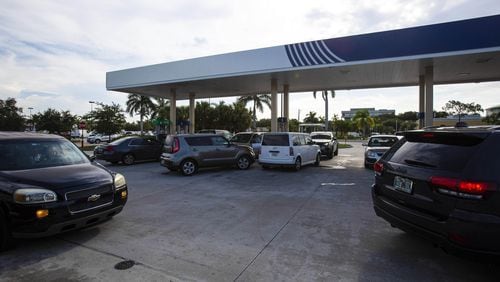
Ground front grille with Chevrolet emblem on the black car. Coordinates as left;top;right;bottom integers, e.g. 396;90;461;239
65;184;114;213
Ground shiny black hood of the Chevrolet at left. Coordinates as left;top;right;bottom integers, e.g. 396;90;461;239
0;164;113;190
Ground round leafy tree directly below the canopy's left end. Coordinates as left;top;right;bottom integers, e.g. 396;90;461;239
92;103;126;141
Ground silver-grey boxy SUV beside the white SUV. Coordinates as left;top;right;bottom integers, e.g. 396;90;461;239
161;134;255;175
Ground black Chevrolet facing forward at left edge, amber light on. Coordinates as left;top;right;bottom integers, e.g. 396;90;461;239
0;132;128;250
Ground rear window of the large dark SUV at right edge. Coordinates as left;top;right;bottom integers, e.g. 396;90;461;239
387;133;484;172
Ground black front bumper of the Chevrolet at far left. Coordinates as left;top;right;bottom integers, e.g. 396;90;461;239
10;188;128;238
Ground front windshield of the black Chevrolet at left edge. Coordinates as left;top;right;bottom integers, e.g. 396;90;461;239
0;140;89;171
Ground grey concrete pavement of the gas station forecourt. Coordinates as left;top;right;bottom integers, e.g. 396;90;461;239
0;142;500;281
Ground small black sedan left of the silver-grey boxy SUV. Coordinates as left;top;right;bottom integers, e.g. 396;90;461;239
94;136;163;165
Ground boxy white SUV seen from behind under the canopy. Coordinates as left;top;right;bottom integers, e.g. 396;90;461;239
259;132;321;170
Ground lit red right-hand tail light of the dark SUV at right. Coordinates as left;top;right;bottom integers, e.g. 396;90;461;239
430;176;494;199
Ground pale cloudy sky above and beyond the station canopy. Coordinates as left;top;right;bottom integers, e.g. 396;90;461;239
0;0;500;120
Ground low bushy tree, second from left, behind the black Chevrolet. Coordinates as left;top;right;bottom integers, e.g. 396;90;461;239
33;108;78;134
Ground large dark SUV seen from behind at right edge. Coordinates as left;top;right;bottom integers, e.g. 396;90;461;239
372;128;500;255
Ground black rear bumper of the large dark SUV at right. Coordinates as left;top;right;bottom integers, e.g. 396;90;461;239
372;185;500;256
